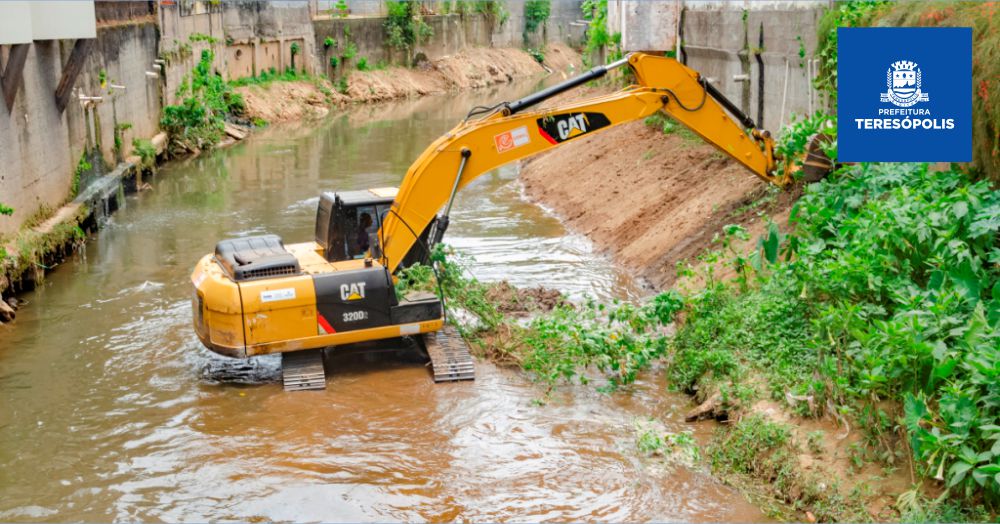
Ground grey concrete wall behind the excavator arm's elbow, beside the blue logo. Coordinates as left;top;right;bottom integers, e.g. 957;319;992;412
608;0;830;131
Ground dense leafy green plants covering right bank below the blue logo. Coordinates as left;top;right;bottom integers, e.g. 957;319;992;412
668;155;1000;501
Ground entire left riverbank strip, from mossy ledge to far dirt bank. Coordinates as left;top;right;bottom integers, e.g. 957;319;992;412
0;44;580;322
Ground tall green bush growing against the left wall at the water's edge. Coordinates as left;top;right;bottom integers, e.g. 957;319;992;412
160;49;246;150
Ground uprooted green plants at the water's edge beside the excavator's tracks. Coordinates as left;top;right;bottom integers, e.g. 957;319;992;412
397;248;682;390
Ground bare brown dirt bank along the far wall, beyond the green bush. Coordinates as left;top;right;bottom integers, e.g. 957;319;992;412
236;44;580;122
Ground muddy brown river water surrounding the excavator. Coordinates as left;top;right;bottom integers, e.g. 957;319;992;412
0;77;764;521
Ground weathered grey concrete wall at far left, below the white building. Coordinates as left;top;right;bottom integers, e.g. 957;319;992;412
0;23;160;234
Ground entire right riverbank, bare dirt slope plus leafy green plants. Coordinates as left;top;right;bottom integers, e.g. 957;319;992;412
506;89;1000;521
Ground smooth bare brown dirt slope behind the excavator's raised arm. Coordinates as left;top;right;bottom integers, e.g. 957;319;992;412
521;121;791;288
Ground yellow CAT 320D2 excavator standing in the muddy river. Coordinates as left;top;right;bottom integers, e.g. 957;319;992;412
191;53;828;390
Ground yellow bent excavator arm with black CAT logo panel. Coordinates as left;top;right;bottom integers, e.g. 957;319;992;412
378;53;789;272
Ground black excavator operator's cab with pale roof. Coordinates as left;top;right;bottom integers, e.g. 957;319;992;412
316;187;397;262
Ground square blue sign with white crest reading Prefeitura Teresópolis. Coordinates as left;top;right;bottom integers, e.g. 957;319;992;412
837;27;972;162
